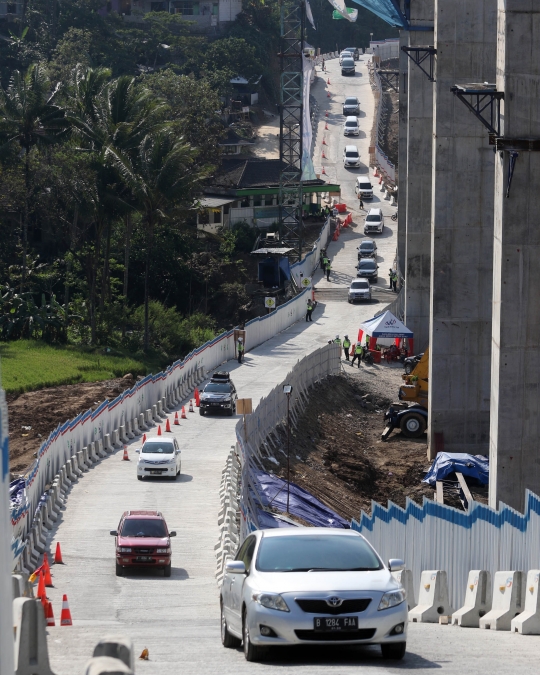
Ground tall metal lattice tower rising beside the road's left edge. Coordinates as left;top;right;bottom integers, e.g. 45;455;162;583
279;0;306;260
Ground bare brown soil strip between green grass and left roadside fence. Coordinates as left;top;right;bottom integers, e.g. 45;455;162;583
7;374;135;474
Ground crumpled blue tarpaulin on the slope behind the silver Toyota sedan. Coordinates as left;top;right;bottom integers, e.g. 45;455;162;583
251;470;351;528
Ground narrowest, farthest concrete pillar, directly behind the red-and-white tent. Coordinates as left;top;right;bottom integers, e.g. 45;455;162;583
400;0;435;352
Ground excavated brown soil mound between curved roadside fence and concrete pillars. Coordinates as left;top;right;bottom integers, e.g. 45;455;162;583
265;368;438;520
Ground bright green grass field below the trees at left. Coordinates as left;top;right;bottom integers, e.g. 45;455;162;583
0;340;166;393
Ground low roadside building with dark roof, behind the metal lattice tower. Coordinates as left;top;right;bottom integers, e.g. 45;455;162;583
197;157;340;232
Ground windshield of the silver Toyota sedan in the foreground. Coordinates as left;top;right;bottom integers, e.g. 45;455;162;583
256;534;382;572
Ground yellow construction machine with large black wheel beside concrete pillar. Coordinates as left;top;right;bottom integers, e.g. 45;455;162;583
381;349;429;441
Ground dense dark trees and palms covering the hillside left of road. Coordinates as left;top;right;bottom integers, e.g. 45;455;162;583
0;0;394;370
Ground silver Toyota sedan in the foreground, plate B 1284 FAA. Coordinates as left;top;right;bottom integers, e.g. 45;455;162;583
220;527;408;661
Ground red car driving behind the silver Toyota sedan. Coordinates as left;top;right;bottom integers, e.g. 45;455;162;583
111;511;176;577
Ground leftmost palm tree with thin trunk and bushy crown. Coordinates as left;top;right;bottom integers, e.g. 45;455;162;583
0;63;67;292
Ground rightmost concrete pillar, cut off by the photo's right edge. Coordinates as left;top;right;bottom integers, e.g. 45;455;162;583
489;0;540;511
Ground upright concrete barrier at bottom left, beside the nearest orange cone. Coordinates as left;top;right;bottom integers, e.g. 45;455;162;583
13;598;53;675
